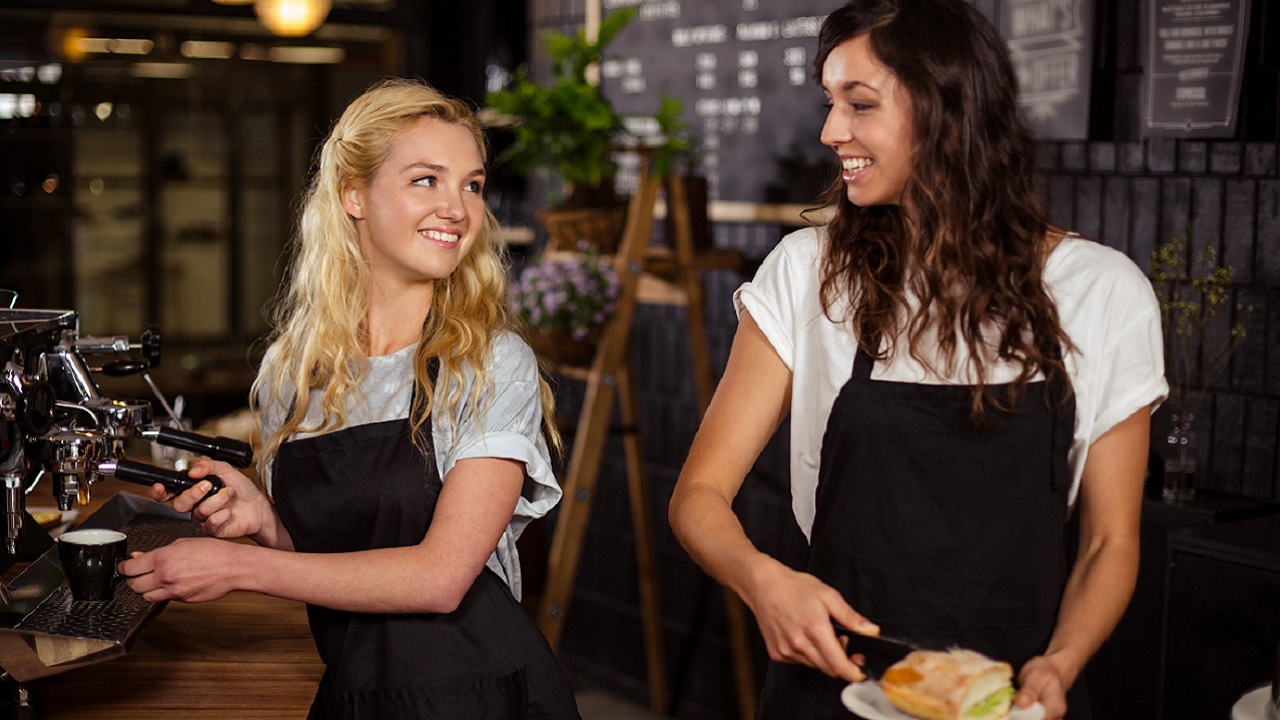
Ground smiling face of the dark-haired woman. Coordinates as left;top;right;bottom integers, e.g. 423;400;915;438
822;35;915;208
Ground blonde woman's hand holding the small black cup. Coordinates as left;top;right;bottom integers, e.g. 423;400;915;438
119;532;243;602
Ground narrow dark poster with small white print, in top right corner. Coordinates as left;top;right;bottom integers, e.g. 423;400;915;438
1146;0;1249;137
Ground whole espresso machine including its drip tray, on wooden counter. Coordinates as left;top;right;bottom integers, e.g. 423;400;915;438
0;307;253;717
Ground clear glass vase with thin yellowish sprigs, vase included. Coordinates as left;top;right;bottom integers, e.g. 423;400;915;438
1149;228;1248;503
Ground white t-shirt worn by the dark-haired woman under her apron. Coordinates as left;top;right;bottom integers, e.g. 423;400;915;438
733;228;1169;537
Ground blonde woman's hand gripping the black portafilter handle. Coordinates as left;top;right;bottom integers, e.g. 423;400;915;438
151;457;292;550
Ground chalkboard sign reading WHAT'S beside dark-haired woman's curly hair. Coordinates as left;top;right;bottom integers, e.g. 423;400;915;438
996;0;1093;140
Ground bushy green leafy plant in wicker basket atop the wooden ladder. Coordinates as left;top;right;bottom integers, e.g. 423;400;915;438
486;8;689;251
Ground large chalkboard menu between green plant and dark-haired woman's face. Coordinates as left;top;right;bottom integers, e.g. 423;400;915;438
600;0;838;202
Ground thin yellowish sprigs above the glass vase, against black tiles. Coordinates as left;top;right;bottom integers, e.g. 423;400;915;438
1149;228;1249;421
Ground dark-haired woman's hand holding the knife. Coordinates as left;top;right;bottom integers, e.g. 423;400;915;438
745;559;879;682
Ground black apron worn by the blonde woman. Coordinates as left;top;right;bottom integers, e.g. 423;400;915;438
274;376;579;720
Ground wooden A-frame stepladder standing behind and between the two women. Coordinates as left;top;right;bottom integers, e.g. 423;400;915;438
538;154;755;720
